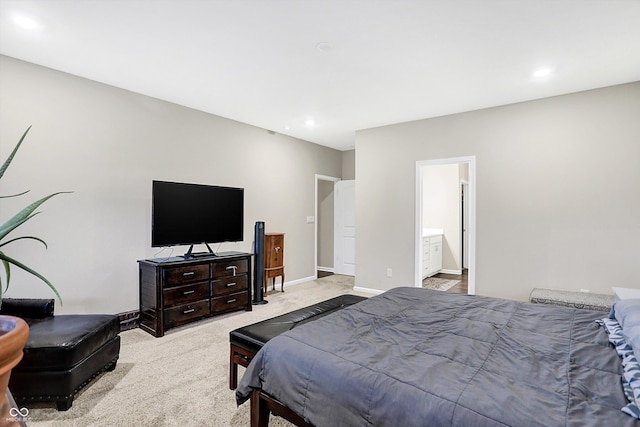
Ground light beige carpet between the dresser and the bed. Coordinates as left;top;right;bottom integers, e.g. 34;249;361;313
26;275;370;427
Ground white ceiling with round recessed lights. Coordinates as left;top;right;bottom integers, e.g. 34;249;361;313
0;0;640;150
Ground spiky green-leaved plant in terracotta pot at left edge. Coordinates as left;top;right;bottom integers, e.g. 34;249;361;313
0;126;62;421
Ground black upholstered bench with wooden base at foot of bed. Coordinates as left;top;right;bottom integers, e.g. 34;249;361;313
229;295;366;390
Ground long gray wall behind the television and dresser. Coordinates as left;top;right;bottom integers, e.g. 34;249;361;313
0;56;342;313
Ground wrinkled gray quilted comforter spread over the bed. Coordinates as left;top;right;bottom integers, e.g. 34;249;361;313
236;288;638;427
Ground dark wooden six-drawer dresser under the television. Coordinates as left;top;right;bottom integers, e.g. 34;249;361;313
138;252;252;337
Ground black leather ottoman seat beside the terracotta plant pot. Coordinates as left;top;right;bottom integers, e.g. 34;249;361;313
2;299;120;411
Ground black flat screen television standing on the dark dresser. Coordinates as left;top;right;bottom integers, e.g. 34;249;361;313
151;181;244;257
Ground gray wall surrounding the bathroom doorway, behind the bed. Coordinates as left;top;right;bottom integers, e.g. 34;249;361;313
356;82;640;300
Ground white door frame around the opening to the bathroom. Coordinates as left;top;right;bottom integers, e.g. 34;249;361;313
414;156;476;295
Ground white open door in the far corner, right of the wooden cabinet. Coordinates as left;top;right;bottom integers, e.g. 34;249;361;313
333;180;356;276
